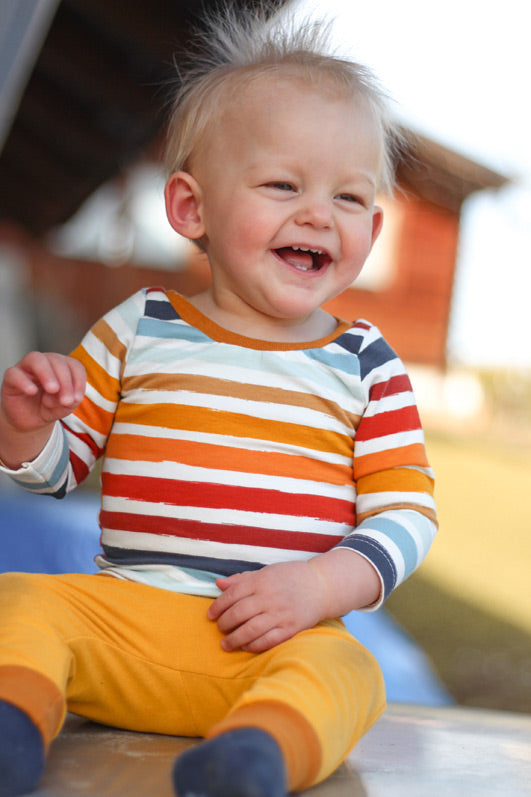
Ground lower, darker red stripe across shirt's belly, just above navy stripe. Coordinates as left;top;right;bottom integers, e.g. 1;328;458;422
100;511;343;553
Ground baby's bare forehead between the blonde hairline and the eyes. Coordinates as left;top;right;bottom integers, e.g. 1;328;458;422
191;75;382;182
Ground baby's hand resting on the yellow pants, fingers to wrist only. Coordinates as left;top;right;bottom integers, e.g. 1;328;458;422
208;562;326;653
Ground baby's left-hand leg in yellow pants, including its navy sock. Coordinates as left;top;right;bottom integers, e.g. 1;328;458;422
0;573;238;797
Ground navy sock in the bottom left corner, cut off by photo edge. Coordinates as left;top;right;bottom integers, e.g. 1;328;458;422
0;700;45;797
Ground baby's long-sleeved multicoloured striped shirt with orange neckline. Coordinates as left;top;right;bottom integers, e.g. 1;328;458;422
5;288;435;599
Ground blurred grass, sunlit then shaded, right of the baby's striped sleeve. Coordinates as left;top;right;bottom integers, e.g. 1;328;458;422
386;435;531;713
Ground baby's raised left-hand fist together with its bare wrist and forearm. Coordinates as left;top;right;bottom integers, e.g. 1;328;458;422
0;352;86;470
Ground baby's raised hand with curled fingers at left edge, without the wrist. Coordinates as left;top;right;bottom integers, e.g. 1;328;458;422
1;352;86;432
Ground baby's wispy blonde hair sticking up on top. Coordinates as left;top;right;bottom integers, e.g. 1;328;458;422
165;3;401;193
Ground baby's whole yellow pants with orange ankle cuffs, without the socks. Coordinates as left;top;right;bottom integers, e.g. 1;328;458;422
0;573;385;790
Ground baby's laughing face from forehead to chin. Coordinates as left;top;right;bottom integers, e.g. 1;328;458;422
190;77;382;336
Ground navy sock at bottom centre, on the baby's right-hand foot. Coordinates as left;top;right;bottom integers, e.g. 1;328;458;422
173;728;287;797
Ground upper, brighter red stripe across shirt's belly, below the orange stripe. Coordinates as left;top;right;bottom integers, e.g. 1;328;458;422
102;473;354;525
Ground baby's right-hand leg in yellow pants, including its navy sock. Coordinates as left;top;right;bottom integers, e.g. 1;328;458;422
174;621;385;797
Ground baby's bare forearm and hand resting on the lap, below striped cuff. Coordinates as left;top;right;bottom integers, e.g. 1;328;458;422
208;548;381;653
